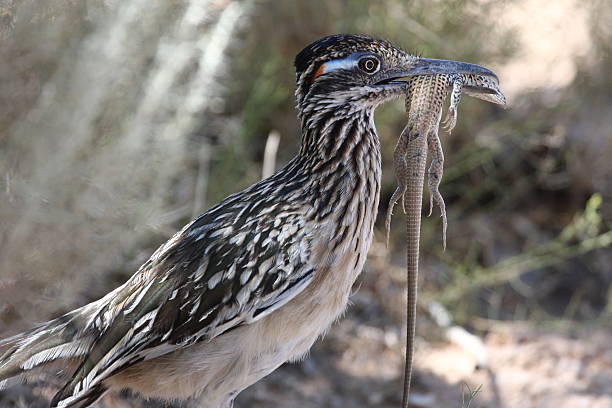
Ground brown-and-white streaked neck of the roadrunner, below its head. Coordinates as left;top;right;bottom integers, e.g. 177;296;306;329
296;105;381;226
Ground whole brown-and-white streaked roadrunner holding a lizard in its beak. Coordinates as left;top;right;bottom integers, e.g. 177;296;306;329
0;35;493;408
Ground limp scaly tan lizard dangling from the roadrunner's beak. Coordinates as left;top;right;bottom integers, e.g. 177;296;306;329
386;74;505;407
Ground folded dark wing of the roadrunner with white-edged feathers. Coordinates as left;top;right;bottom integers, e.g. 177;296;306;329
52;197;314;407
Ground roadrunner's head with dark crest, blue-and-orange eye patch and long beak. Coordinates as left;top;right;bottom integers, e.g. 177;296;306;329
295;34;498;114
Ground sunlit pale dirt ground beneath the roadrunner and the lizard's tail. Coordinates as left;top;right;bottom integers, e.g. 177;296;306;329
0;289;612;408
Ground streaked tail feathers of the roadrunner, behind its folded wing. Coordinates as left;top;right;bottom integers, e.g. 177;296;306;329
0;305;94;390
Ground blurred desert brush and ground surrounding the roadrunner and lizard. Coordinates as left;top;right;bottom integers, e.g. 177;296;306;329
0;0;612;408
